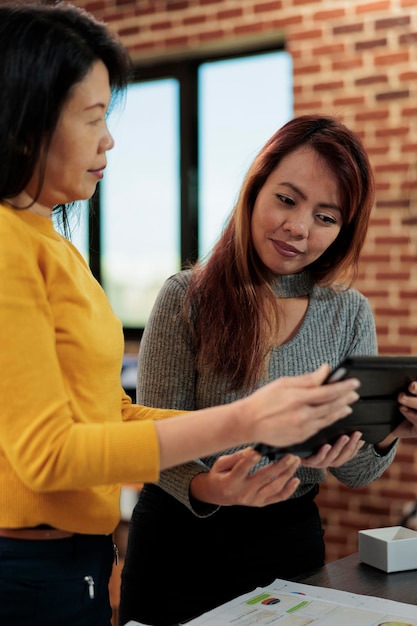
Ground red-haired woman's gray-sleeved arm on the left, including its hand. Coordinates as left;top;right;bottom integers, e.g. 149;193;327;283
138;273;358;508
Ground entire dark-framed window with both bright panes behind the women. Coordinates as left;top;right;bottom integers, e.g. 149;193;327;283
80;44;293;339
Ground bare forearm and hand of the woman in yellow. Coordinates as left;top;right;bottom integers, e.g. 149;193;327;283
155;365;360;468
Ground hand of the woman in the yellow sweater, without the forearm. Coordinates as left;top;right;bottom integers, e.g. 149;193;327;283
240;364;360;447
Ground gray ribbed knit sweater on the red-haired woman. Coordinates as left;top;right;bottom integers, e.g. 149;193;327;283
137;270;397;517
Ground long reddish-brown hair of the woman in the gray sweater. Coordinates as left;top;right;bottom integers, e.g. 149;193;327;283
185;115;374;389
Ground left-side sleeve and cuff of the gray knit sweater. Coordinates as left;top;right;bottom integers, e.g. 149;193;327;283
137;272;218;516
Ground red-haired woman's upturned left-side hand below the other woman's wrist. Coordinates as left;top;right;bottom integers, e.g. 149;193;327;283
190;447;300;507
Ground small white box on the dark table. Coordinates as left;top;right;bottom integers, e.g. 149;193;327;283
358;526;417;572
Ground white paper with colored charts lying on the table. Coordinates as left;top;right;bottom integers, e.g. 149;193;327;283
188;579;417;626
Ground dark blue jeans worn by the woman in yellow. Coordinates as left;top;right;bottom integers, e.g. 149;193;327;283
0;535;114;626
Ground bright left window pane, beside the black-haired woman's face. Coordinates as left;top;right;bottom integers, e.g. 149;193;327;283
100;79;181;327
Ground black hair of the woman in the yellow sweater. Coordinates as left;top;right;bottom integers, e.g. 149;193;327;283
0;2;131;230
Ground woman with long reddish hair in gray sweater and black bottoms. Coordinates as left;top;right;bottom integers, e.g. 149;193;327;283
120;115;414;626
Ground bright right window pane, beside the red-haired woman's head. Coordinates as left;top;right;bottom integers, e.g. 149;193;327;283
198;52;293;257
